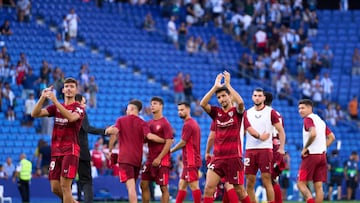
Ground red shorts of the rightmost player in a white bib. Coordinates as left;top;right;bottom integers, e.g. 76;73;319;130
298;153;328;182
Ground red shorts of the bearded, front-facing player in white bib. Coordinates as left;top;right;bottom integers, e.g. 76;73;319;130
244;149;273;175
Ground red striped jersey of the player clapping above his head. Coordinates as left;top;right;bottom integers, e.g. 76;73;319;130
209;106;243;159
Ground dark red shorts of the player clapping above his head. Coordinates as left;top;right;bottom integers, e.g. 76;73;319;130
208;157;244;185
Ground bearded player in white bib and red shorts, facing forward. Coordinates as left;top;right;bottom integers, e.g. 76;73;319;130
244;88;285;203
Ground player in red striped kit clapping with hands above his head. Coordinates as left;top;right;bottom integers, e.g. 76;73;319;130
200;71;268;203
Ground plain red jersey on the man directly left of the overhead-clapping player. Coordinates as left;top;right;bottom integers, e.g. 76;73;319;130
181;118;202;168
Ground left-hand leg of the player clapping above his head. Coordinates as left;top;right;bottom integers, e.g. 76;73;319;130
204;169;220;203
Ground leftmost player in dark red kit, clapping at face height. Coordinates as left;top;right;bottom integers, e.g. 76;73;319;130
31;78;84;203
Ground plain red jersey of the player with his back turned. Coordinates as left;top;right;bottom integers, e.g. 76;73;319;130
115;115;150;167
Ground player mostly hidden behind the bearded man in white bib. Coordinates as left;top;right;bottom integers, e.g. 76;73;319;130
264;92;286;203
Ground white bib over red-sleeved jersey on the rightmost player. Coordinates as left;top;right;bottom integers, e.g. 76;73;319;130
303;113;332;154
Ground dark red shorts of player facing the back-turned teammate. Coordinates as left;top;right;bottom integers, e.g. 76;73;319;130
141;163;170;186
